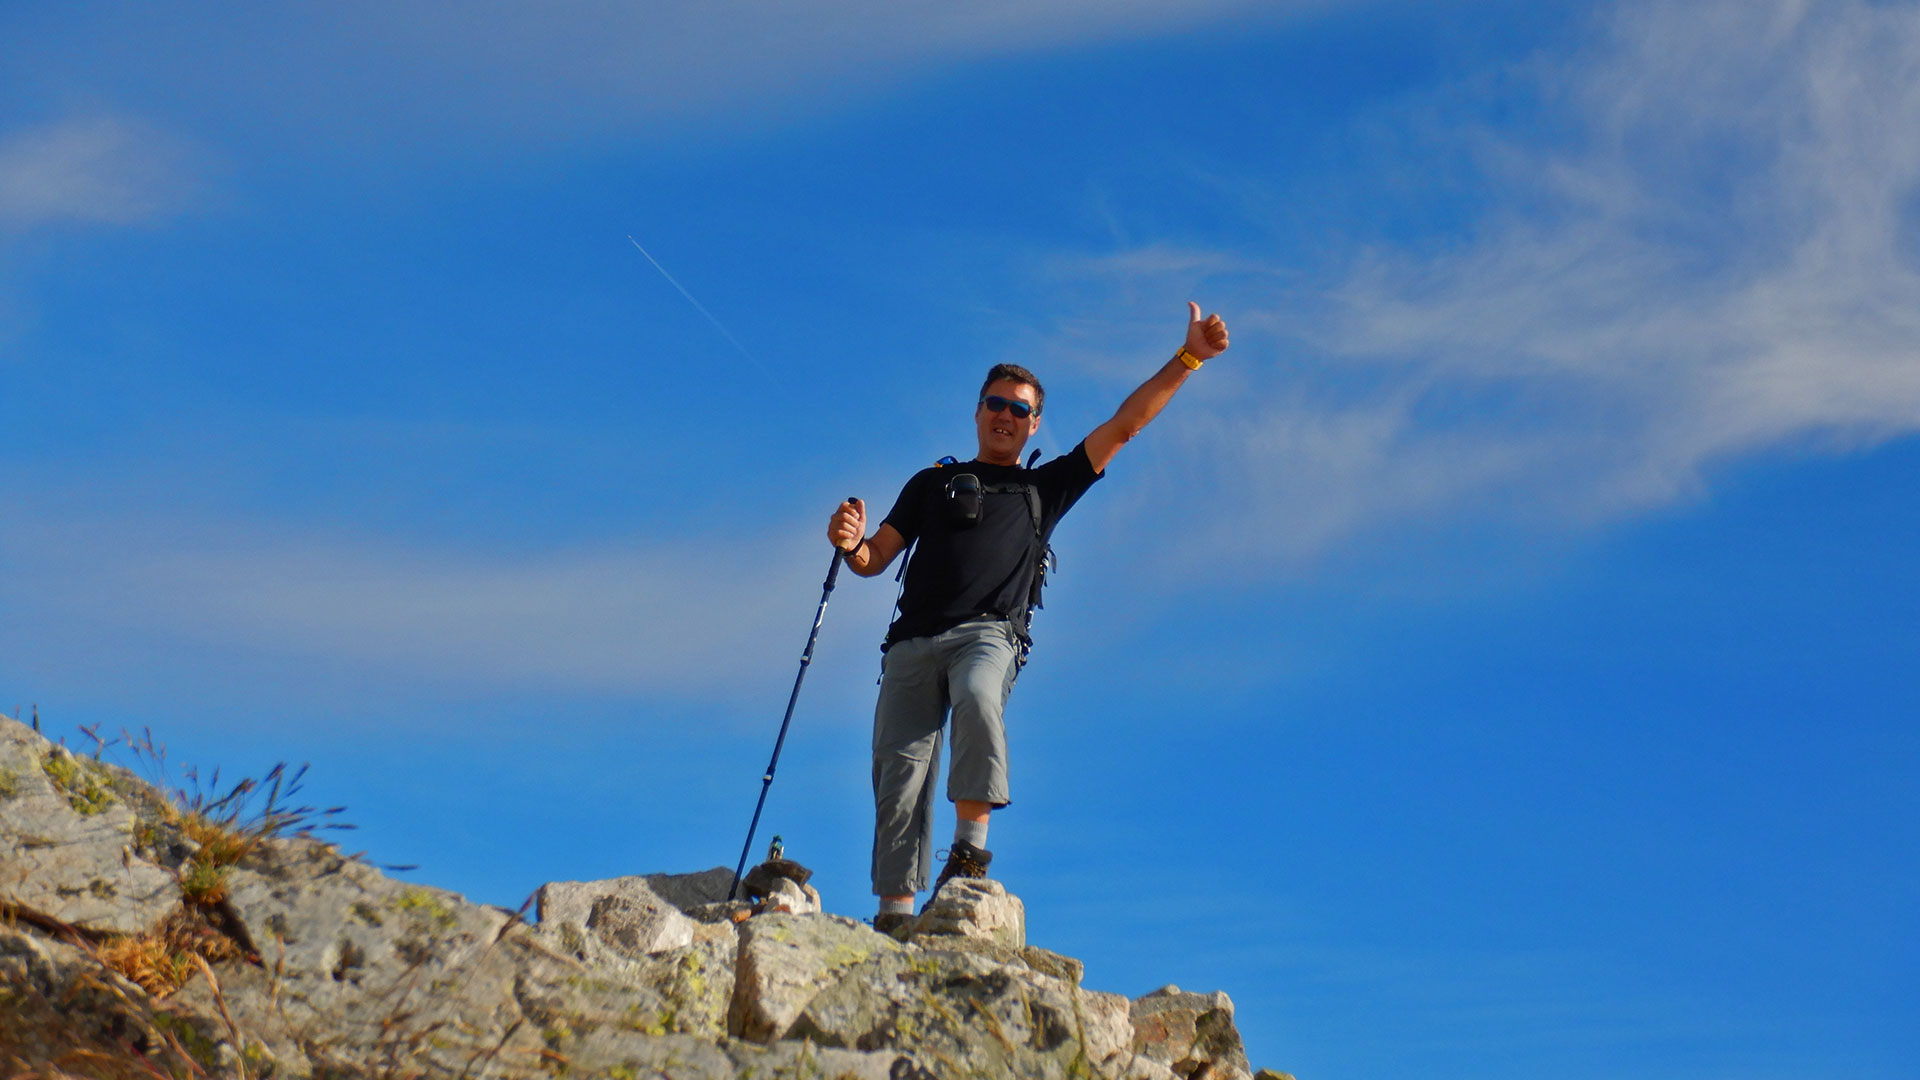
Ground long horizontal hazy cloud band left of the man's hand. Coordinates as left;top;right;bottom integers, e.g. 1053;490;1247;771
0;515;891;705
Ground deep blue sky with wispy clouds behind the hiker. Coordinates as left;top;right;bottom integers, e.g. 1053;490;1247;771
0;0;1920;1080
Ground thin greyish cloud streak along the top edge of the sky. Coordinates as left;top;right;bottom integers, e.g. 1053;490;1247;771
0;0;1352;150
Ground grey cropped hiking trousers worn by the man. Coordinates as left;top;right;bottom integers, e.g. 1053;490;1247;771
874;617;1020;896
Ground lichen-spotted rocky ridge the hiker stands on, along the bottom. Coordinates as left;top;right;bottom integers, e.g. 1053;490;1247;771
0;719;1290;1080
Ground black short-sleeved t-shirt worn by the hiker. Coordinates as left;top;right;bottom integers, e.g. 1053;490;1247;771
885;442;1100;644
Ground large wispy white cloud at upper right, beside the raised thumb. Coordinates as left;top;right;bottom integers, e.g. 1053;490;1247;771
1062;0;1920;567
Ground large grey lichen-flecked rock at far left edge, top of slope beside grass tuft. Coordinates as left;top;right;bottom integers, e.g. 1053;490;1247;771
0;719;180;934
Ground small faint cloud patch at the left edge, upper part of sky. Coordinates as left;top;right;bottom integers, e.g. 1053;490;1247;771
0;117;198;227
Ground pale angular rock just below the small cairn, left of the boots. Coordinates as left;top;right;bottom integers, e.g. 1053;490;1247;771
728;915;900;1043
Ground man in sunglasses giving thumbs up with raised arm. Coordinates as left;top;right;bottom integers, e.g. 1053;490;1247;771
828;302;1227;932
